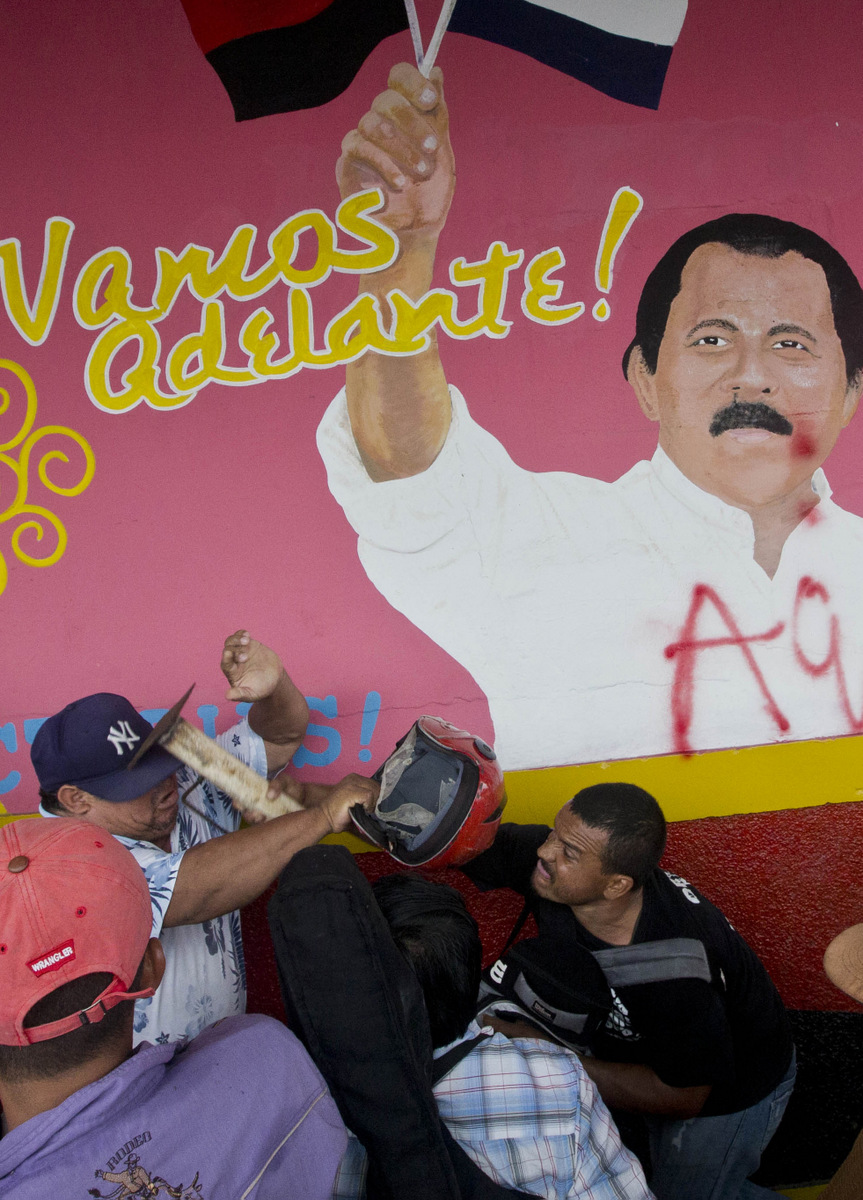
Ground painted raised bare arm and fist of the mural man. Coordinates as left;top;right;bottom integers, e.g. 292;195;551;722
336;62;455;481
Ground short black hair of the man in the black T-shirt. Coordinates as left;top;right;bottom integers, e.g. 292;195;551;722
569;784;666;888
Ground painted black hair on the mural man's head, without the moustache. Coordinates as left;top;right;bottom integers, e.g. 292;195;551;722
623;212;863;385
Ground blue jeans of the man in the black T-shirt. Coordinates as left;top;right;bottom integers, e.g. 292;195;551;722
647;1054;797;1200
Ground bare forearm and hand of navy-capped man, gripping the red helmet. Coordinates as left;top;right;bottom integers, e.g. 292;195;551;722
164;775;379;926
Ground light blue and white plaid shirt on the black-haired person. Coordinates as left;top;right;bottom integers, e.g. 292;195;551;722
332;1022;652;1200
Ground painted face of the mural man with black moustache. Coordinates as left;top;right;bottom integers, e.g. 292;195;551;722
629;242;861;510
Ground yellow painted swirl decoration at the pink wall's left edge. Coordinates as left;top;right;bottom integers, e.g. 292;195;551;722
0;359;96;594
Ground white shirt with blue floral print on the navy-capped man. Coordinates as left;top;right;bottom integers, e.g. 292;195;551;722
118;720;266;1045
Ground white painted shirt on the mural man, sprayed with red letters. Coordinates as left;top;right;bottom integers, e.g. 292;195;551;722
318;388;863;769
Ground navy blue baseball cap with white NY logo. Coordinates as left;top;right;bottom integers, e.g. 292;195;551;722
30;691;182;802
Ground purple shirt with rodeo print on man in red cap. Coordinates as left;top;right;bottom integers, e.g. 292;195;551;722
0;1016;347;1200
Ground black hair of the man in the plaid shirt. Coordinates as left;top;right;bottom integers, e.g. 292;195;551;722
372;872;483;1049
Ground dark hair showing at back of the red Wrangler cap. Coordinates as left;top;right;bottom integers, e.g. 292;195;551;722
0;962;143;1084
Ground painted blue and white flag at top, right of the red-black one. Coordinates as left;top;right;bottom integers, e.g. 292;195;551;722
449;0;687;108
